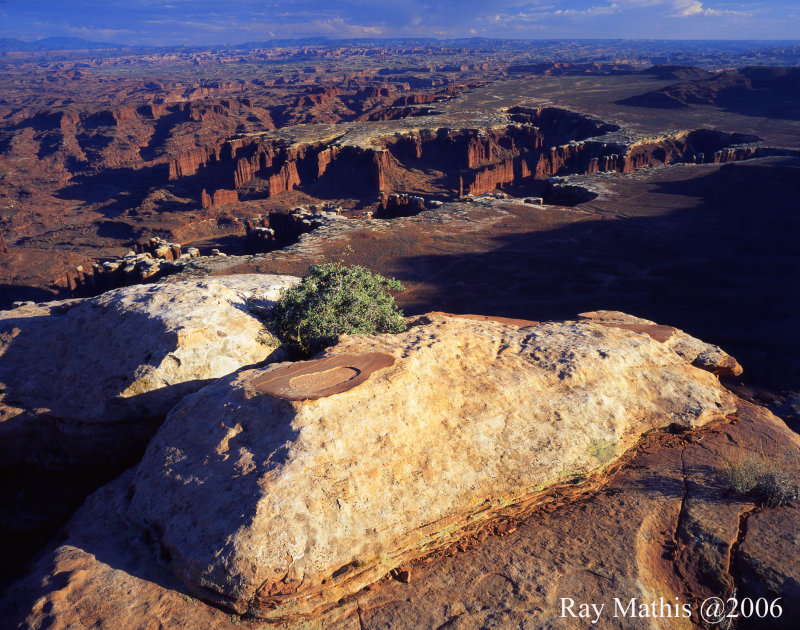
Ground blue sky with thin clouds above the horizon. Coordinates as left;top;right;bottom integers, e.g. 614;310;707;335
0;0;800;45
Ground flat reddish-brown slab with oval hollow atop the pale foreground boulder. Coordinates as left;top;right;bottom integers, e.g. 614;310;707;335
252;352;394;400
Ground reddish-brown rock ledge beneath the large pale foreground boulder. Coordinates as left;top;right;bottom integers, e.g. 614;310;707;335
0;400;800;630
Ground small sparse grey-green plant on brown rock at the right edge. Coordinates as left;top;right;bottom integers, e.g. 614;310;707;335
721;455;800;505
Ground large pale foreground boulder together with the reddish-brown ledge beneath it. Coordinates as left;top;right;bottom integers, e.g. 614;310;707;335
7;314;800;630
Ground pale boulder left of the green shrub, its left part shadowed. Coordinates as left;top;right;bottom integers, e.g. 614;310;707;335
0;275;298;466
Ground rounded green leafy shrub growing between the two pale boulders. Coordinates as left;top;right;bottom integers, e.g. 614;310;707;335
260;261;406;357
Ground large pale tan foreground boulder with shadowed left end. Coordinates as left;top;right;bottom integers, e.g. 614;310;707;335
128;314;733;618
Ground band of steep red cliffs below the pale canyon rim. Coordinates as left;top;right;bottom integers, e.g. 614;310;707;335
161;107;788;209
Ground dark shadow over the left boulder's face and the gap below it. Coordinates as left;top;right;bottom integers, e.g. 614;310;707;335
0;297;228;596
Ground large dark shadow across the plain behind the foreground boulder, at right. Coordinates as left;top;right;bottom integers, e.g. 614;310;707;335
397;159;800;396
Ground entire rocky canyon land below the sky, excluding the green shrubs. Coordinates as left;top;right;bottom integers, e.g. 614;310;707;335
0;41;800;630
